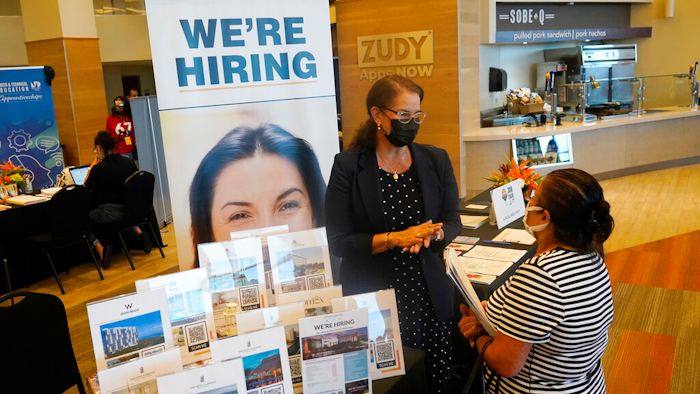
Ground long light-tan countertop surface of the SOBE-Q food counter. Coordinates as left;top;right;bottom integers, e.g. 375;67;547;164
462;107;700;142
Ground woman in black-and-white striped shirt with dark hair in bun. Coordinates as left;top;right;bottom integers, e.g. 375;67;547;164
459;169;614;394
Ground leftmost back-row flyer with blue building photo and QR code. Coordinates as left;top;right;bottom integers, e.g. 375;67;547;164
197;237;267;338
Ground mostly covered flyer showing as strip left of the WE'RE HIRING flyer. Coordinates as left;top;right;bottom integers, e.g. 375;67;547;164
236;302;305;394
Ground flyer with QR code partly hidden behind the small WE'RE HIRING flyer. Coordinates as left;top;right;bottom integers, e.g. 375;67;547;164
332;289;406;380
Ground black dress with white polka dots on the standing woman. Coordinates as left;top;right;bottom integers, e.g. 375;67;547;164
379;166;452;393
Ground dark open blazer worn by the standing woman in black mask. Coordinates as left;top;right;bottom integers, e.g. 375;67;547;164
325;143;462;321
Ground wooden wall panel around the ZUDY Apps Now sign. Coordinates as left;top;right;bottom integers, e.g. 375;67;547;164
335;0;462;187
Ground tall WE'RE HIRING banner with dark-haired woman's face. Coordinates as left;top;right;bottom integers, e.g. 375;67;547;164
146;0;338;269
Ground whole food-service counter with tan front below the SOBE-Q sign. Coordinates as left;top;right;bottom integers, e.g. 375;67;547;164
461;107;700;197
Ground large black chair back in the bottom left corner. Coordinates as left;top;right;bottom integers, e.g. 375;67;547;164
0;292;85;394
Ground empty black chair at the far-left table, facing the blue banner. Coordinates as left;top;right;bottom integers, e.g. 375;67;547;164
25;185;104;294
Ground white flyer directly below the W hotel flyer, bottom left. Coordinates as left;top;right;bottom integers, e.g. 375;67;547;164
97;349;182;394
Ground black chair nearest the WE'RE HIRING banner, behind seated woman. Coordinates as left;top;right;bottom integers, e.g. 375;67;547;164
115;171;165;270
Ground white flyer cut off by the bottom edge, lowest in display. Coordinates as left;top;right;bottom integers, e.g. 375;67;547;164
158;358;249;394
